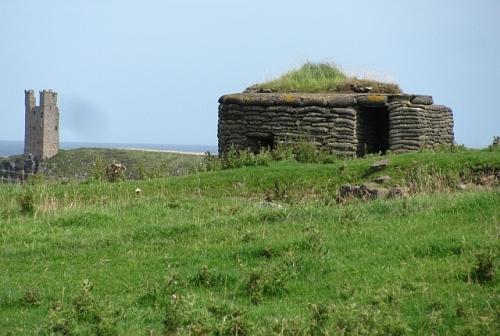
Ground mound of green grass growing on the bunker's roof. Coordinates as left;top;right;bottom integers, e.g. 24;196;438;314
254;62;401;93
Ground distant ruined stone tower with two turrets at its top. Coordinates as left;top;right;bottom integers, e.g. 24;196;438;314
24;90;59;160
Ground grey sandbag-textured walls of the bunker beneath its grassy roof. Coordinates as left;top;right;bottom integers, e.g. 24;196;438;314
218;93;453;156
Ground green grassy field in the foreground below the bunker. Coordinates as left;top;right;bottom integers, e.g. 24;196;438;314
0;150;500;335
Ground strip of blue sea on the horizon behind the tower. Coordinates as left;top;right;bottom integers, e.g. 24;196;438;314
0;140;217;157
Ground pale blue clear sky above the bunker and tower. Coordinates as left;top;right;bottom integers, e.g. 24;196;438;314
0;0;500;147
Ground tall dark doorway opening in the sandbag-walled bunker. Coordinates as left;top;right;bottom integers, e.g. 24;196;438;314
356;107;389;156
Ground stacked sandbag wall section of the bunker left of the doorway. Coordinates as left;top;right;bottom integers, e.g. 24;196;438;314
218;104;357;155
